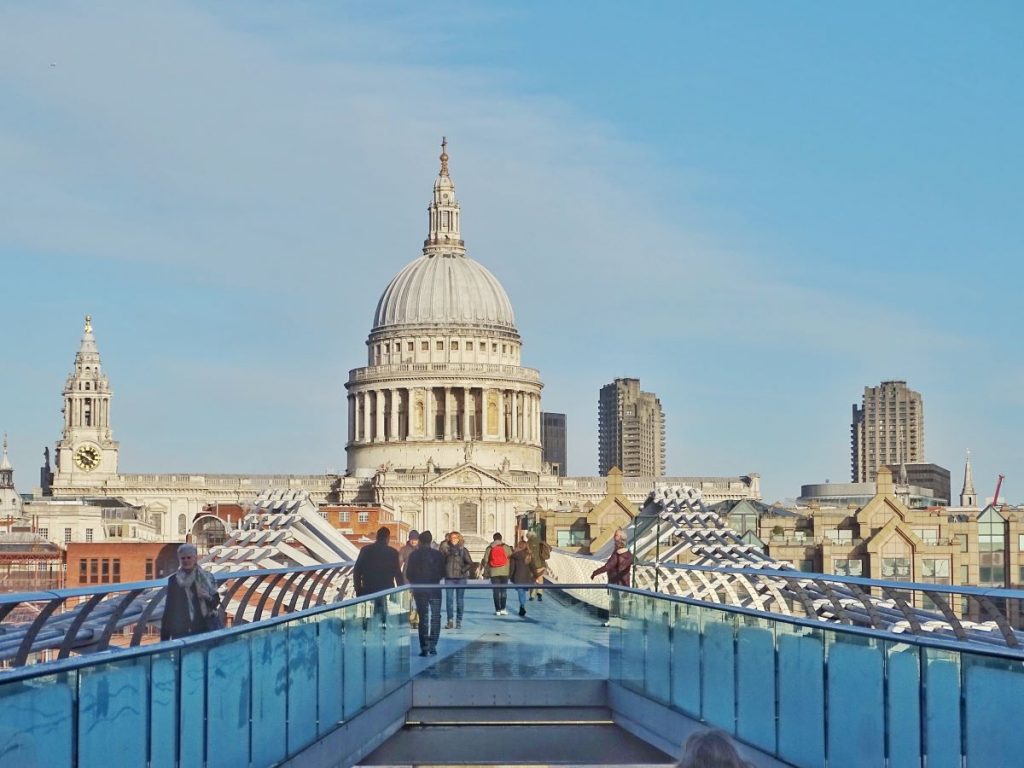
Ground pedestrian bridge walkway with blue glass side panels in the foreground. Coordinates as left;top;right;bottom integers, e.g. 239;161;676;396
0;571;1024;768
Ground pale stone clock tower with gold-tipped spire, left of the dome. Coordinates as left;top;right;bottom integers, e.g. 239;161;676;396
53;315;118;488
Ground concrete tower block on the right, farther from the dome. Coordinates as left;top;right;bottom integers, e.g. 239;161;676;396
850;381;925;482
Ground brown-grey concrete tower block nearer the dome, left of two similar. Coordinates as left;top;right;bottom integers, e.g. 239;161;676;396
597;379;665;477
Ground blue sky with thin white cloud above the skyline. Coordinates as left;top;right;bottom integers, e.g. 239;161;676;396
0;2;1024;502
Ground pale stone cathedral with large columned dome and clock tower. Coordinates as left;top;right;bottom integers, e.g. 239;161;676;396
43;142;761;541
